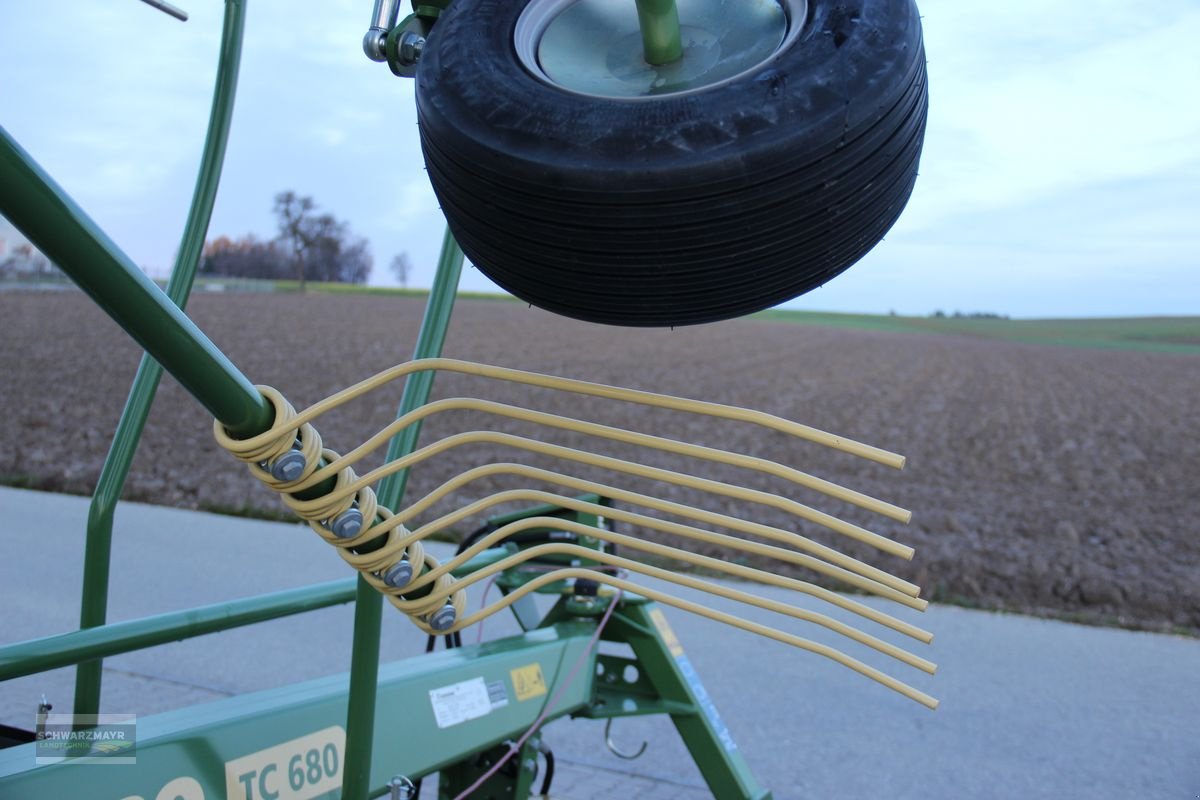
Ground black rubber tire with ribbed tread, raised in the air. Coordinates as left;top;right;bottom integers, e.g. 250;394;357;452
416;0;928;326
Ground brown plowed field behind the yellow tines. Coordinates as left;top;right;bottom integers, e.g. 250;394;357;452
0;291;1200;632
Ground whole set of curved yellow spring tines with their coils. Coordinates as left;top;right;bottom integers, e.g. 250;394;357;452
217;359;937;708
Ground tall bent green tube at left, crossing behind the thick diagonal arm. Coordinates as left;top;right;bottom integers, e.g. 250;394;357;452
74;0;246;714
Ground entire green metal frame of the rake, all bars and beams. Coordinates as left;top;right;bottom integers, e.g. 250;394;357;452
0;0;770;800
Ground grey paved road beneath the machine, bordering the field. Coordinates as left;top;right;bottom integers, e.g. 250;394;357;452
0;488;1200;800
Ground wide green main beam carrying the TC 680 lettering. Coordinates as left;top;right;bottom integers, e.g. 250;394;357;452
0;624;595;800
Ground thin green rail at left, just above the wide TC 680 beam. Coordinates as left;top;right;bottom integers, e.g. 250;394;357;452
0;578;354;680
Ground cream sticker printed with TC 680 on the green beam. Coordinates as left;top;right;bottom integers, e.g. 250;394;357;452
224;726;346;800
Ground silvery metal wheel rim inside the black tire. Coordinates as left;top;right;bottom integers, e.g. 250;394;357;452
512;0;808;100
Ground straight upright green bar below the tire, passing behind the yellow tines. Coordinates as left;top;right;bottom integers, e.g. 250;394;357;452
342;228;463;800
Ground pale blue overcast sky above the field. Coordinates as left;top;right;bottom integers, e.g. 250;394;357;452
0;0;1200;317
